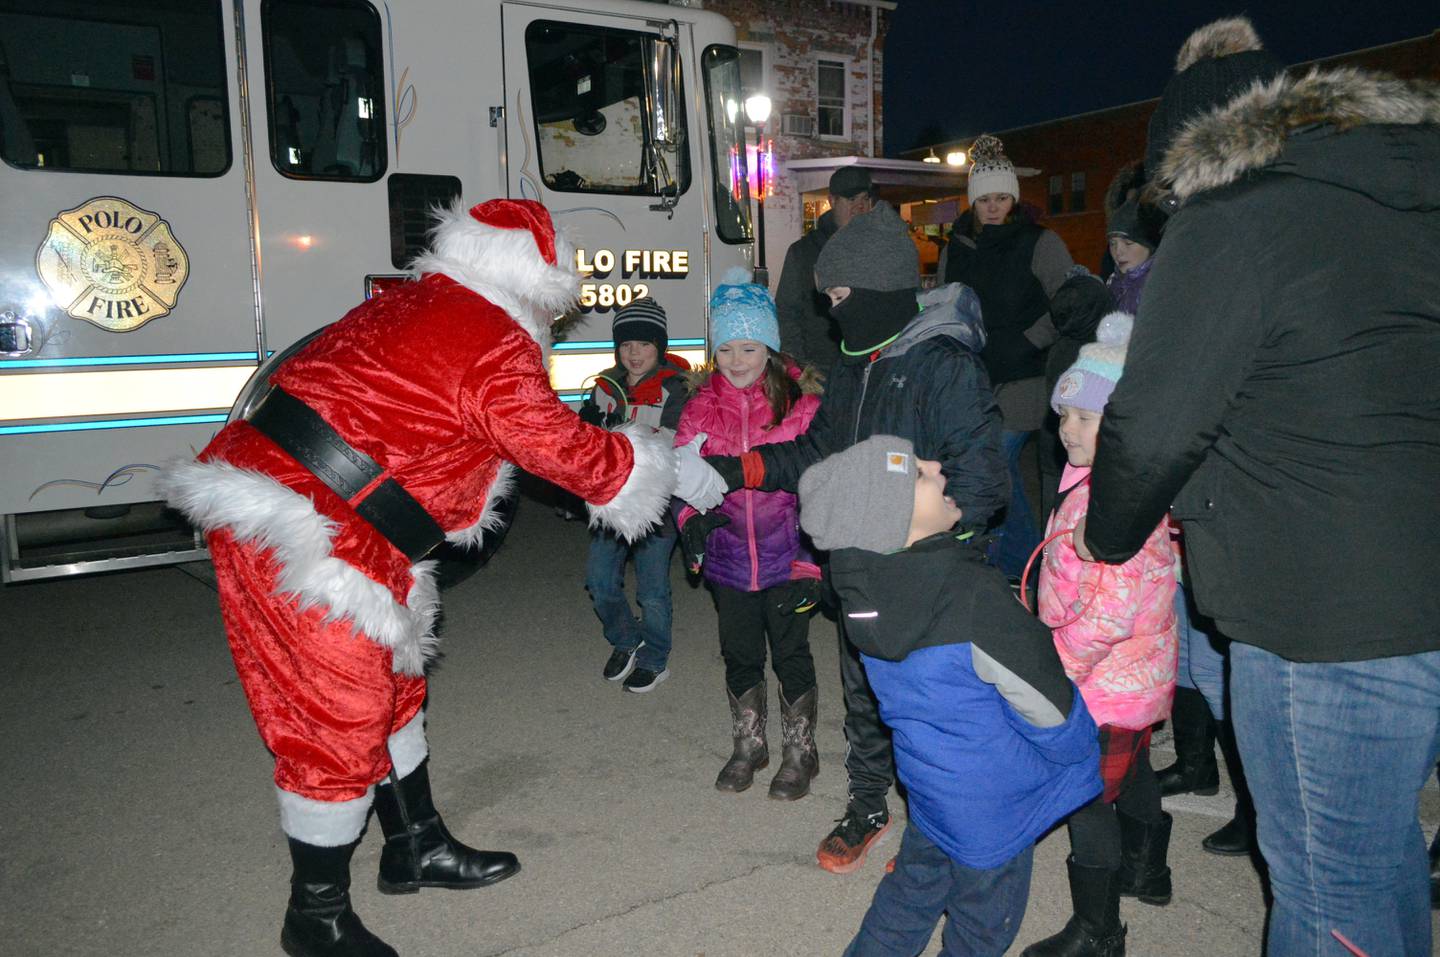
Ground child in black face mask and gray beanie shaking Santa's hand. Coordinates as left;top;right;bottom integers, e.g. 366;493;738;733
688;203;1009;874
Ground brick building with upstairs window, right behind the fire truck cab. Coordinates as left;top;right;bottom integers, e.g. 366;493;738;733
670;0;896;281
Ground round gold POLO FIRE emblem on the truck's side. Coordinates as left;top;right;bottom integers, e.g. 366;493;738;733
35;196;190;332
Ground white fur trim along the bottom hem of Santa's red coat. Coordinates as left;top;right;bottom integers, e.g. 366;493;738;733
157;461;439;675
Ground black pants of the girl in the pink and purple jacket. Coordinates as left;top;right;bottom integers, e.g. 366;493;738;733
710;583;815;701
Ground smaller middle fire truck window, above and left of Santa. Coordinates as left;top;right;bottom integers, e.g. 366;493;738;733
261;0;386;183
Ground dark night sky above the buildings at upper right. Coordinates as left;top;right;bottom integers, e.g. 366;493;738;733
884;0;1440;155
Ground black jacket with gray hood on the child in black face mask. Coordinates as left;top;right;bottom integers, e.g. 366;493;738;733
756;285;1009;528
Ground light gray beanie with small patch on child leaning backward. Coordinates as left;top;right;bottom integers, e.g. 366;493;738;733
799;435;917;554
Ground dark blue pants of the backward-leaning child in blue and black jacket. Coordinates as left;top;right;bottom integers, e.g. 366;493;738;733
844;825;1032;957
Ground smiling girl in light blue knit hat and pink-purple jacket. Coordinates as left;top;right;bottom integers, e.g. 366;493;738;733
675;269;819;800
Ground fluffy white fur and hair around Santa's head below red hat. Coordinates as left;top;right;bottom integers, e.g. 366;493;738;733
410;200;580;345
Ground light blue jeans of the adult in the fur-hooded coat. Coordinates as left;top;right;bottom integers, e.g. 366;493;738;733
1230;642;1440;957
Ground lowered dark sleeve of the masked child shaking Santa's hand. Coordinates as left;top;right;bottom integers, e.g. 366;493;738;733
920;347;1009;527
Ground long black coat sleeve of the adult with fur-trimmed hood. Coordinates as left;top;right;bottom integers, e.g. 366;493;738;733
1084;200;1264;564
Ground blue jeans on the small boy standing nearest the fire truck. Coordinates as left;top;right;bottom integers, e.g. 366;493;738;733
585;525;675;672
